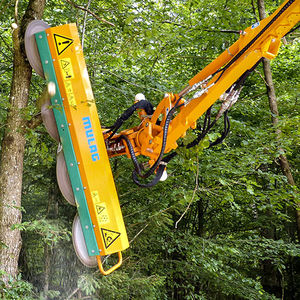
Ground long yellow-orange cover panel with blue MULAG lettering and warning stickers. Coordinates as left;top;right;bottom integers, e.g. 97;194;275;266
46;24;129;264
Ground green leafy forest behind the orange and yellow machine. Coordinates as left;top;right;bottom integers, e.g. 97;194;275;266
0;0;300;300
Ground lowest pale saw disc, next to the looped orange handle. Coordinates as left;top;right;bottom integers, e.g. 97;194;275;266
72;215;98;268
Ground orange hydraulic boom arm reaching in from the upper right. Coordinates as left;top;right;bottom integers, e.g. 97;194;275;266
104;0;300;178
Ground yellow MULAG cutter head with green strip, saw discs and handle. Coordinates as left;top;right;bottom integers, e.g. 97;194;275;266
25;20;129;275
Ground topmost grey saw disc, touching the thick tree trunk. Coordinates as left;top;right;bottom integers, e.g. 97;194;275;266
24;20;50;78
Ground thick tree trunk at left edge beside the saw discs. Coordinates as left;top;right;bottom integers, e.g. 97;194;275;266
0;0;45;282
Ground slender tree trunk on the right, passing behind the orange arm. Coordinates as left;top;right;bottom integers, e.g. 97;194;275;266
257;0;300;242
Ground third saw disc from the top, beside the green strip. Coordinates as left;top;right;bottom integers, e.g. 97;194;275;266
56;151;76;206
